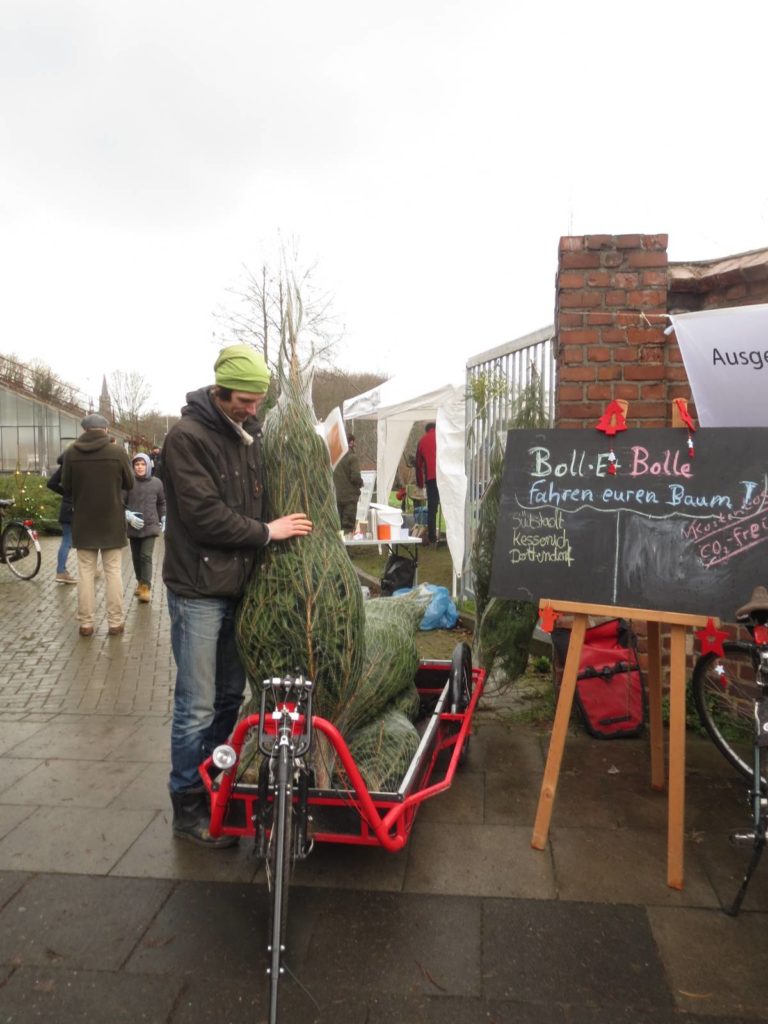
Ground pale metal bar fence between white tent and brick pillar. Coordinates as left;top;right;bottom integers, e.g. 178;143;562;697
462;327;555;597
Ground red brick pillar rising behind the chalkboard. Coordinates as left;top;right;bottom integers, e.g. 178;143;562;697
555;234;690;428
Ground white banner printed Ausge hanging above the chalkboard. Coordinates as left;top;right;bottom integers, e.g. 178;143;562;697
670;305;768;427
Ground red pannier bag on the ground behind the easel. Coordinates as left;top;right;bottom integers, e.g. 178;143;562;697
552;618;645;739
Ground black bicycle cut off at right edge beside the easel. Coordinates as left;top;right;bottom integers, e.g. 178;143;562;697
692;587;768;916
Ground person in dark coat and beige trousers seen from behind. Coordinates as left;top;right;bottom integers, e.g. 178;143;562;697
61;413;133;637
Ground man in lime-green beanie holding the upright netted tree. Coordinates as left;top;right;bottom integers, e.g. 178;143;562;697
161;345;312;849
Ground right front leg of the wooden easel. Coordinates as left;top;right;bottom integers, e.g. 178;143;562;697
667;626;685;889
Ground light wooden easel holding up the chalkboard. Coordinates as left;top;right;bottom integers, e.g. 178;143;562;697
530;599;711;889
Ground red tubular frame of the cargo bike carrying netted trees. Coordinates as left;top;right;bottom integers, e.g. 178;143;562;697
200;669;485;853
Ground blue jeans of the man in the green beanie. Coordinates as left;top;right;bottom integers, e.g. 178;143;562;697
166;590;246;793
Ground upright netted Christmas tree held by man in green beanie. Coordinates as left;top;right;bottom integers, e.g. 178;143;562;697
238;350;365;721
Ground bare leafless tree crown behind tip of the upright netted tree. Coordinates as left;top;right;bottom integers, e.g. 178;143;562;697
214;240;343;368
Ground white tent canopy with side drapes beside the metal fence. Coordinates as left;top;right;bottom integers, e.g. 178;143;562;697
343;365;467;574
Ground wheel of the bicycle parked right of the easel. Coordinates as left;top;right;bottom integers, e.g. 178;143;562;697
691;640;759;779
